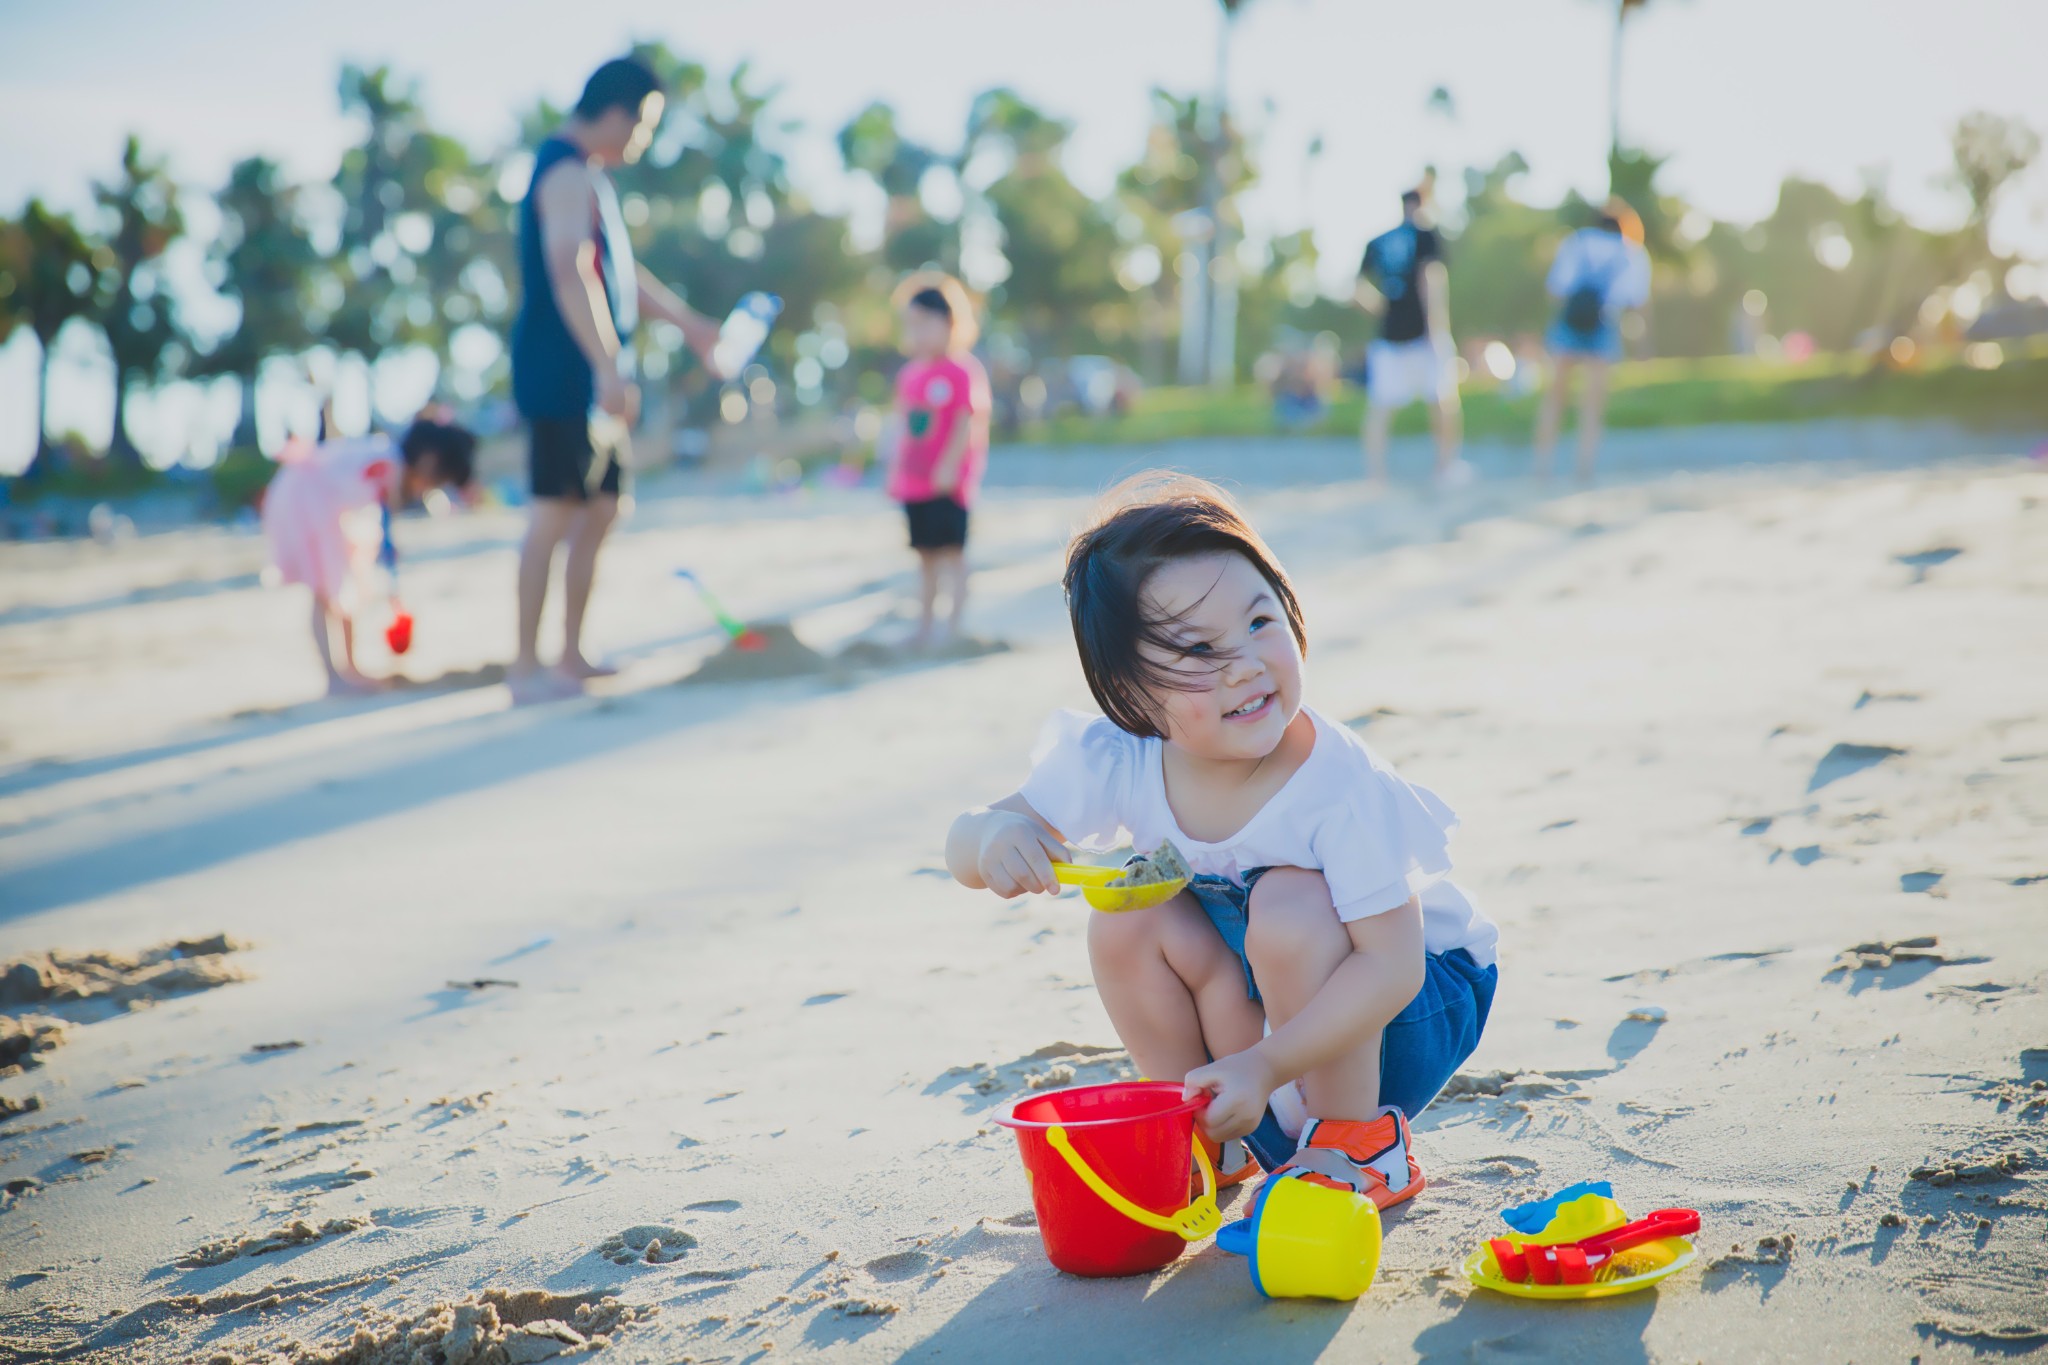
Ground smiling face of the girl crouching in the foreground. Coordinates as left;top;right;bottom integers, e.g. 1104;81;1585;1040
1141;553;1303;761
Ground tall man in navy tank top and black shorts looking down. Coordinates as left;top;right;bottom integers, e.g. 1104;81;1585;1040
508;57;719;702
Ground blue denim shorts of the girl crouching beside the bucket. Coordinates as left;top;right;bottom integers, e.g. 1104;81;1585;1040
1188;868;1501;1117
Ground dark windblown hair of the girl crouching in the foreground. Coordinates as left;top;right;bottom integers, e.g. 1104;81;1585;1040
1061;475;1309;739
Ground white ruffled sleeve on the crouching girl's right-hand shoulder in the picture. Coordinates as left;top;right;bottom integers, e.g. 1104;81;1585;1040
1315;753;1458;921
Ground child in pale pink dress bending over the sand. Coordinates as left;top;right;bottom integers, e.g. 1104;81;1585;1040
262;417;477;694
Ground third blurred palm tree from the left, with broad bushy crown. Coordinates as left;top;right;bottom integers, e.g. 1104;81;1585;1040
195;156;322;446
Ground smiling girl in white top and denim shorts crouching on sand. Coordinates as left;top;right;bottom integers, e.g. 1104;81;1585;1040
946;479;1499;1207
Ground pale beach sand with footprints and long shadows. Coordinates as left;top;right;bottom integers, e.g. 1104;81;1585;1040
0;432;2048;1365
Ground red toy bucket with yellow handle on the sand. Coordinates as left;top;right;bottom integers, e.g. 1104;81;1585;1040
995;1081;1223;1275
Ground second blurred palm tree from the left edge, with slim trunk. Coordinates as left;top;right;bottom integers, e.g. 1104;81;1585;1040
92;135;184;469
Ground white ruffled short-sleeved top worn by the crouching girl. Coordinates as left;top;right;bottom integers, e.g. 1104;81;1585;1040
1020;706;1499;966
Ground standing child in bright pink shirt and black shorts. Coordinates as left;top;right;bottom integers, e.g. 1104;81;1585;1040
881;272;991;649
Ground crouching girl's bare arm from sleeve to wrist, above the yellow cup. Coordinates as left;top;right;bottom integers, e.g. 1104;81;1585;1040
1251;896;1423;1087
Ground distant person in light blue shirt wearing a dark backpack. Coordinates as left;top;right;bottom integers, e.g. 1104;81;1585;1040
1534;199;1651;483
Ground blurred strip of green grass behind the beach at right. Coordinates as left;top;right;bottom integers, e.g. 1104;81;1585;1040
1018;344;2048;444
